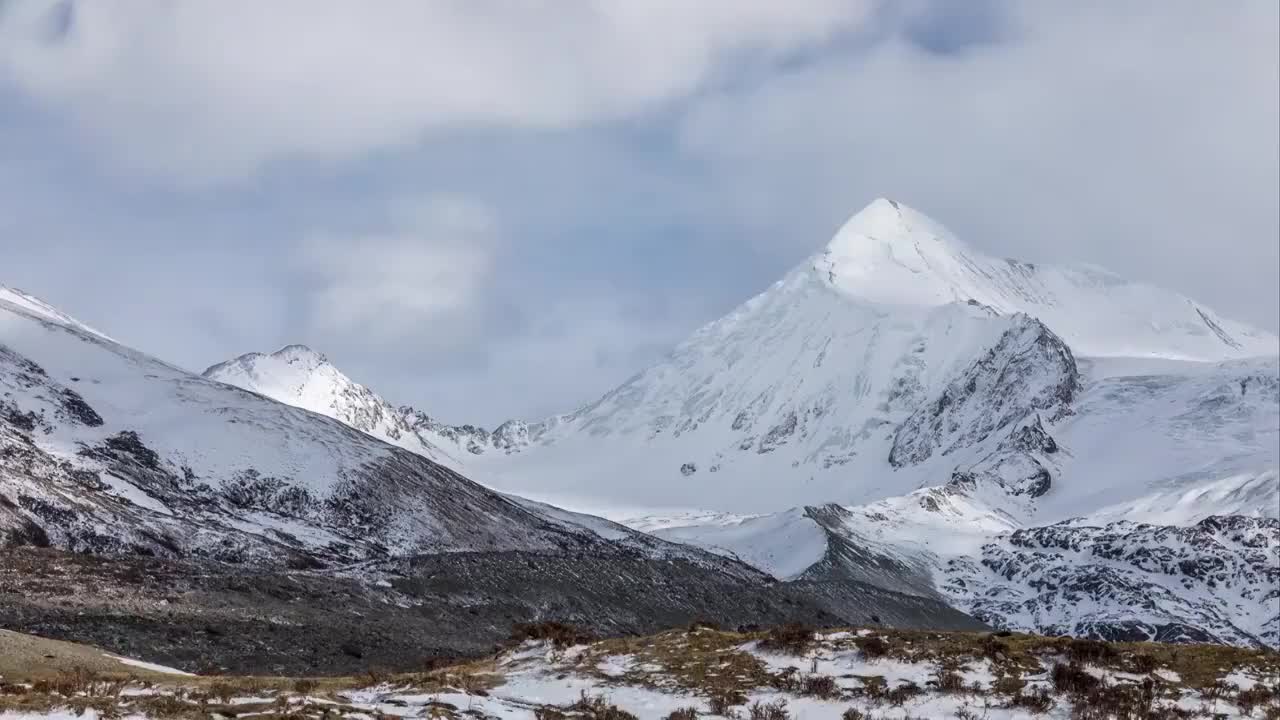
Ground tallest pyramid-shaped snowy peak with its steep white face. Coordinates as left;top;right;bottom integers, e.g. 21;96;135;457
425;200;1280;512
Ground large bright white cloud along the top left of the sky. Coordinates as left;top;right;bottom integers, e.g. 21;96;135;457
0;0;870;182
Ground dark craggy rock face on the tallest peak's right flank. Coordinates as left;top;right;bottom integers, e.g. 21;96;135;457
888;315;1080;468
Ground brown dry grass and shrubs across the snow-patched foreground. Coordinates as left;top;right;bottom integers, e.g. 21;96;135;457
0;623;1280;720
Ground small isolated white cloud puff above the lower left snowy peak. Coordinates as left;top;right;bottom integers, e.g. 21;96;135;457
298;195;498;342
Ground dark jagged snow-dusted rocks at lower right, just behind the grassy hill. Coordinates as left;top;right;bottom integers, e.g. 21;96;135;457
945;515;1280;647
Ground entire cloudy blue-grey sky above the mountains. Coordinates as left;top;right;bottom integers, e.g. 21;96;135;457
0;0;1280;423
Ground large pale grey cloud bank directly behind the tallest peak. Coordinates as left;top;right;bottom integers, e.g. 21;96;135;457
681;0;1280;329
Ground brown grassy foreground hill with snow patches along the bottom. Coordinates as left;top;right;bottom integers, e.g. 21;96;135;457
0;625;1280;720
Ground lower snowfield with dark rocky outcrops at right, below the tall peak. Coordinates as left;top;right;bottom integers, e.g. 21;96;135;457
640;359;1280;647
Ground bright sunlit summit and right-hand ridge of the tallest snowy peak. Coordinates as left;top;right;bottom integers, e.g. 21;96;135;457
804;197;1277;361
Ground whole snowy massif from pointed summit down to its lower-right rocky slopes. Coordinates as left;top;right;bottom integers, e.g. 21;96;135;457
204;200;1280;644
